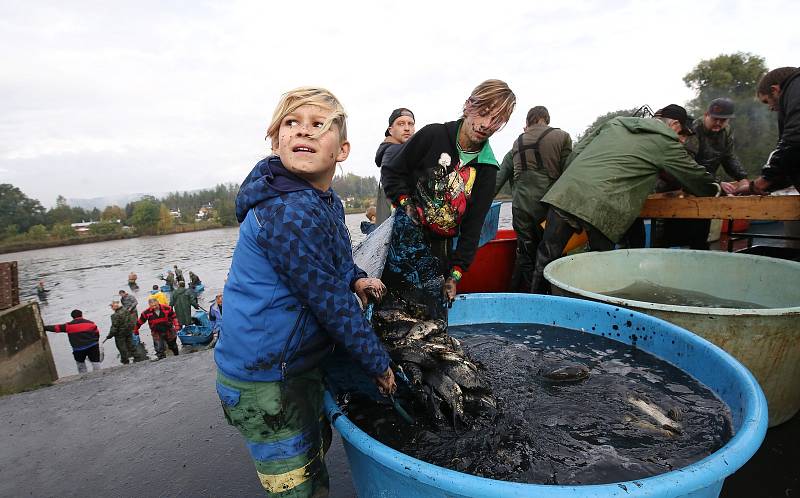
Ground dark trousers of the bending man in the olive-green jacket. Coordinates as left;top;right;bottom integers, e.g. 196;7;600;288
531;208;614;294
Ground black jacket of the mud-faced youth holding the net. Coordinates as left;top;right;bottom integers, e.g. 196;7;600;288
381;120;498;270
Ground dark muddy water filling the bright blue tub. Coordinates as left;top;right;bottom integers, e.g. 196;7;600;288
347;324;732;484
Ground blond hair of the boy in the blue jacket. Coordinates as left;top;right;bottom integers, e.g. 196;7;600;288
267;86;347;147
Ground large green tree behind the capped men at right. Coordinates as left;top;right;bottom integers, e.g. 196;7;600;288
683;52;778;177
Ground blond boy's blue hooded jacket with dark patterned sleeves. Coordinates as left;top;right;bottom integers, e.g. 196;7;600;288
214;156;389;382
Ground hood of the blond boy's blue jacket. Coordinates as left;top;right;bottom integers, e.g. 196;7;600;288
236;156;332;223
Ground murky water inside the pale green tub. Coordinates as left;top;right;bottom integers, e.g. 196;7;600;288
603;280;767;309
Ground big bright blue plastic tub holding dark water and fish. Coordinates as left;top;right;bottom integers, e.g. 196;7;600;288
325;294;767;498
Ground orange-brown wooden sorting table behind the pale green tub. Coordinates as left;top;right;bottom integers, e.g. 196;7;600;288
639;192;800;252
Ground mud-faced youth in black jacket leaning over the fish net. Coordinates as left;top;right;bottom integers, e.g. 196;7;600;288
381;79;516;303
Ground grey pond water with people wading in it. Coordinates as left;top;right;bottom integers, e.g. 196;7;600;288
0;203;511;377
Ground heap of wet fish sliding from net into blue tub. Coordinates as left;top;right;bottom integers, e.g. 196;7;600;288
373;309;497;426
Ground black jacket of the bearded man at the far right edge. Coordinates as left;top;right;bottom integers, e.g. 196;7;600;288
761;70;800;189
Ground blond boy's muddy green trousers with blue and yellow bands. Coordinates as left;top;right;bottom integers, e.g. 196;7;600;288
217;369;331;498
